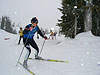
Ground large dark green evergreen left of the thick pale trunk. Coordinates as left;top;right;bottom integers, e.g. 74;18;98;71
57;0;85;38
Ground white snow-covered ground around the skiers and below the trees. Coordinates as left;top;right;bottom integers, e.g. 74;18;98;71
0;30;100;75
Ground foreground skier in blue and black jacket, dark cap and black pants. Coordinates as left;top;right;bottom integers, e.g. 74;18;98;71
23;17;47;68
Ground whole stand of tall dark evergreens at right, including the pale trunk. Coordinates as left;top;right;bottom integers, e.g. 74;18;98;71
57;0;100;38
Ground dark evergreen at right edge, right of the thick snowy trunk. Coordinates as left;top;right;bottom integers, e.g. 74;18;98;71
92;0;100;36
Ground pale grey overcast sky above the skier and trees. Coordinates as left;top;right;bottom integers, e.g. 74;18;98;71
0;0;61;28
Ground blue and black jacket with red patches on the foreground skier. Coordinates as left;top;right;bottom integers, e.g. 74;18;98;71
23;24;44;39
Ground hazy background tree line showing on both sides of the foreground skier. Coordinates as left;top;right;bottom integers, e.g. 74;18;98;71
0;16;53;34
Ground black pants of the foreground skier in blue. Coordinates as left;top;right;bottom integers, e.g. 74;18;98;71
23;38;39;59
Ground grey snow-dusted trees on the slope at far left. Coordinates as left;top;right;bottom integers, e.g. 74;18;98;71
0;16;17;34
